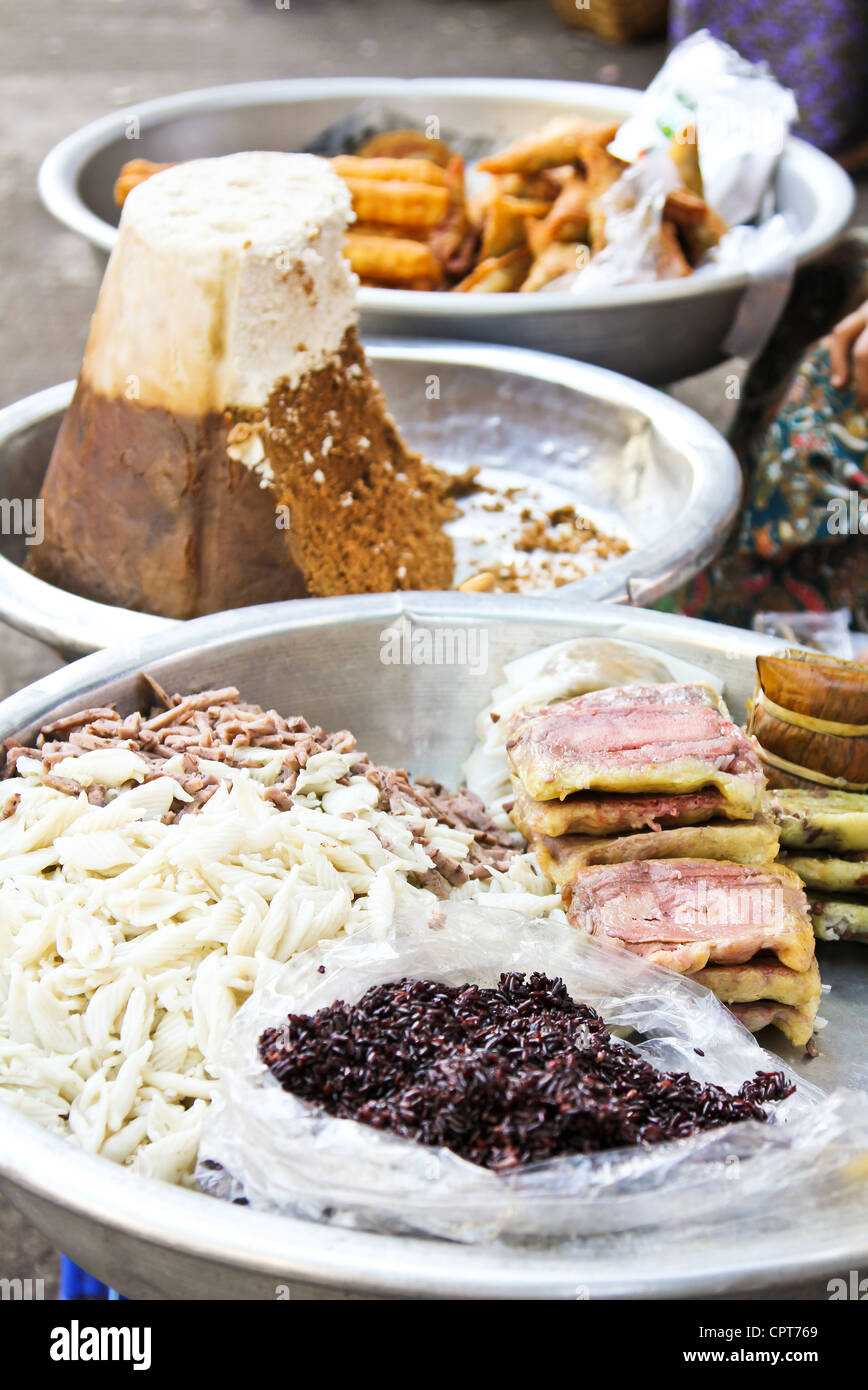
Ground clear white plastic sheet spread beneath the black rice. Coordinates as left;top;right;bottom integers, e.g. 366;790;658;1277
196;904;868;1243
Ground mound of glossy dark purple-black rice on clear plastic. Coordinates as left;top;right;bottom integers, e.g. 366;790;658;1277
259;973;794;1169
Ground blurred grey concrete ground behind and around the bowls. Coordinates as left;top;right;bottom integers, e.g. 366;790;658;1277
0;0;868;1297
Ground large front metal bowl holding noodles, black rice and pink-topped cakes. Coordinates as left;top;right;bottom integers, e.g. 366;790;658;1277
0;594;868;1300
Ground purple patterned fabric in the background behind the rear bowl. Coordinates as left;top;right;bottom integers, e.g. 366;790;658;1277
669;0;868;153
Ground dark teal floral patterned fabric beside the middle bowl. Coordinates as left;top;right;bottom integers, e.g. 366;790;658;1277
662;234;868;631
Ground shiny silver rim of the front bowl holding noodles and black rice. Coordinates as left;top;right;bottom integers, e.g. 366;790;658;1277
0;594;868;1298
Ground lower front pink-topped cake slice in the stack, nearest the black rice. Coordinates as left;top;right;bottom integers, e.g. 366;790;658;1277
565;859;814;974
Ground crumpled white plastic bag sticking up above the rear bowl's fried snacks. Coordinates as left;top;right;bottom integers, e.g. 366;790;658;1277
609;29;798;227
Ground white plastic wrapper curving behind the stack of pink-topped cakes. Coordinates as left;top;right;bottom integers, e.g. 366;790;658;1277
462;637;723;830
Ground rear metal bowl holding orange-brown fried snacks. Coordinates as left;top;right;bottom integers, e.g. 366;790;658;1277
39;78;854;384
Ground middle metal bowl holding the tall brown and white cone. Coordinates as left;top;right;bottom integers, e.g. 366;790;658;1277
0;342;741;655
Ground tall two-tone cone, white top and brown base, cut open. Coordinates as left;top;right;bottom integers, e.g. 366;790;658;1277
31;153;453;619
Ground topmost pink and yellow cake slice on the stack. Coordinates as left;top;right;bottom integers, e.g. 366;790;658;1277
506;682;762;817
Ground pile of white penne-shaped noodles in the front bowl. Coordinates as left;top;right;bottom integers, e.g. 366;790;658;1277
0;748;562;1183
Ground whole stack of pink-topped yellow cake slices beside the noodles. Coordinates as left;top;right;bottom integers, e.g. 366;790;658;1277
506;684;819;1043
